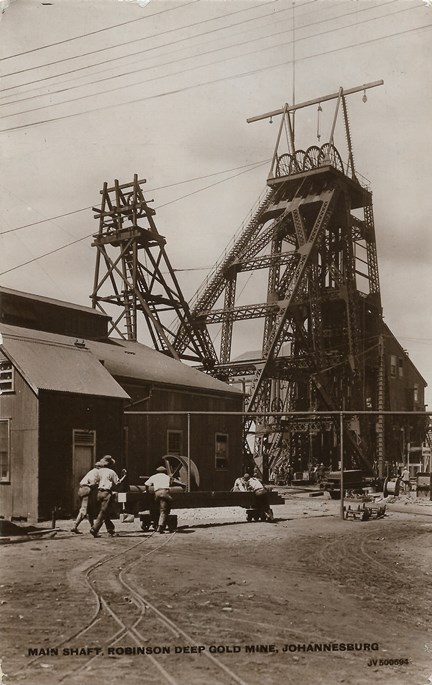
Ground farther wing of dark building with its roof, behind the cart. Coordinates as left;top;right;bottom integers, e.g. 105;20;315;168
87;339;243;490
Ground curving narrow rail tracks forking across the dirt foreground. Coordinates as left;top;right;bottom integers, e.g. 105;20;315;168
10;532;248;685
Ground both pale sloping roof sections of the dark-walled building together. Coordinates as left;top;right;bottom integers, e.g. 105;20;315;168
0;324;242;398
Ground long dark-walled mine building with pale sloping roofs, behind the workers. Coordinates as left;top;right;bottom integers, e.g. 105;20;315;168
0;288;243;521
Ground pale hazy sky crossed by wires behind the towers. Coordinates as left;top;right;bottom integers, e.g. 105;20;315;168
0;0;432;400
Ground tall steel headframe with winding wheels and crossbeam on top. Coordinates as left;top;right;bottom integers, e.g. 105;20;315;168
174;82;385;477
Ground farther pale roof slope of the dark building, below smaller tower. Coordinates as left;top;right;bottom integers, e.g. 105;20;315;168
86;339;242;396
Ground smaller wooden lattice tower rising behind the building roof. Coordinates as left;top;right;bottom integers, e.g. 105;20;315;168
91;175;217;368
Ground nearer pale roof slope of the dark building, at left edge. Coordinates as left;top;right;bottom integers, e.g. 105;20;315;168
0;324;129;399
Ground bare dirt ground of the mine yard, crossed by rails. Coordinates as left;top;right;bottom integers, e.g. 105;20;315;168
0;492;432;685
